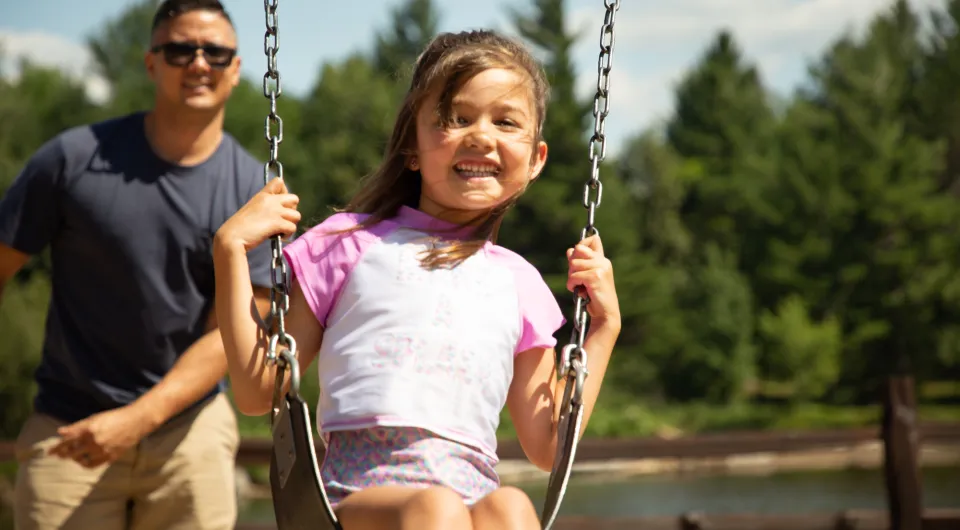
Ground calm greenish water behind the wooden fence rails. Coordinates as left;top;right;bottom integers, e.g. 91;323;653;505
240;468;960;522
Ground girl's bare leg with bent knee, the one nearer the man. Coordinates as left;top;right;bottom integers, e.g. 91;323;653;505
335;486;473;530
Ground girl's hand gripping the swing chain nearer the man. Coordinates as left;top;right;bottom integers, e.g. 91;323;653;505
217;178;300;254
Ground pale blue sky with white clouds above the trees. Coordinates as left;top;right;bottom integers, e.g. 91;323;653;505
0;0;943;156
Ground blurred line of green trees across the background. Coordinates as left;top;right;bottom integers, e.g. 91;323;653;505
0;0;960;438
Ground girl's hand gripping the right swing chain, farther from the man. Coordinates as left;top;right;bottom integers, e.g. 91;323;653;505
567;235;620;328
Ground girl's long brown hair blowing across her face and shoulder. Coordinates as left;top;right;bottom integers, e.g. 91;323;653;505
341;30;549;268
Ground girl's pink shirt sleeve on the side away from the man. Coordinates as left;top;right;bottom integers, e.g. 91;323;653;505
514;262;566;354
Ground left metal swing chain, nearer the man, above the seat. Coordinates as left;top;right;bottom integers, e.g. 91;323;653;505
263;0;300;414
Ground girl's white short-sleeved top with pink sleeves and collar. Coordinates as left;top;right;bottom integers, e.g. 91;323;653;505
284;207;564;459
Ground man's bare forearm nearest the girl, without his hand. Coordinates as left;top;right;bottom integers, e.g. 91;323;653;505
125;287;270;432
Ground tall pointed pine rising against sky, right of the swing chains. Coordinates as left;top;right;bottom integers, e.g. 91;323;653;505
648;31;777;402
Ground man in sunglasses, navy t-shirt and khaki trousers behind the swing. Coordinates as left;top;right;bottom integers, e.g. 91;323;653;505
0;0;270;530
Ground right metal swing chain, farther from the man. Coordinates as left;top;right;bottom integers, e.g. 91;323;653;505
557;0;620;401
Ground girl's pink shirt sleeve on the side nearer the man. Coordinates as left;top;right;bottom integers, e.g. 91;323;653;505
283;213;364;327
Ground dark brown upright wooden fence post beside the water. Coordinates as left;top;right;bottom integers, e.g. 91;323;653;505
883;376;923;530
